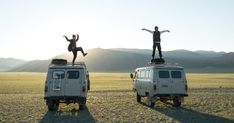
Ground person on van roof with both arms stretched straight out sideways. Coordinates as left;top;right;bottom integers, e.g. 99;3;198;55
142;26;170;59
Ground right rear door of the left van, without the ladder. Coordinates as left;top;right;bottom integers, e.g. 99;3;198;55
64;69;84;96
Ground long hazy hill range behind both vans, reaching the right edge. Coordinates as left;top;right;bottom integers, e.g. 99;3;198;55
3;48;234;72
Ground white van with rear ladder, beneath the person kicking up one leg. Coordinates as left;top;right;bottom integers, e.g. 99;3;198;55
44;59;90;111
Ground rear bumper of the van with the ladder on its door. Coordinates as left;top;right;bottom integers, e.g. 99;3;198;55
44;96;86;103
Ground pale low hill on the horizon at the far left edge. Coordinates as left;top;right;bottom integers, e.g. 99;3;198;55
0;58;27;71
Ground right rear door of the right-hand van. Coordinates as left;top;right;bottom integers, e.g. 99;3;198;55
171;70;186;94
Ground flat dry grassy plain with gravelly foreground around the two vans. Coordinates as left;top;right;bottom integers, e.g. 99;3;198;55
0;72;234;123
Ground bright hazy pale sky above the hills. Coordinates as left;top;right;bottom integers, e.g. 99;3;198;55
0;0;234;60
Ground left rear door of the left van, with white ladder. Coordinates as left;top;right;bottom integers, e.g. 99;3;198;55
49;69;65;96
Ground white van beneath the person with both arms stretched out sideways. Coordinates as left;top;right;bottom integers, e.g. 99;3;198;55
130;64;188;107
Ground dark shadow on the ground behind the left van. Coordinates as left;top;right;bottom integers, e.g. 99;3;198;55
39;107;96;123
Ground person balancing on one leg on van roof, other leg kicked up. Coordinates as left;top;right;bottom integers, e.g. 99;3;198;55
63;34;88;65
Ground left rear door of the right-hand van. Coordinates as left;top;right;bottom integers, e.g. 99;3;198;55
155;69;171;94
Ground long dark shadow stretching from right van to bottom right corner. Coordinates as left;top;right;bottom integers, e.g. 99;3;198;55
153;104;234;123
